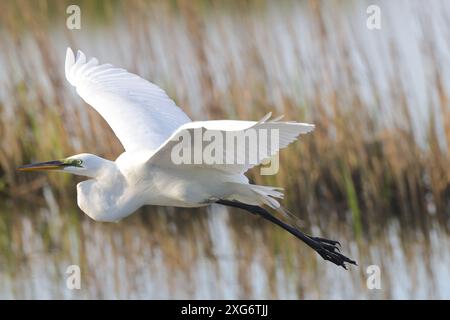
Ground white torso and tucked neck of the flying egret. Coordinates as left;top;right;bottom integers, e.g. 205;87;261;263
77;152;248;222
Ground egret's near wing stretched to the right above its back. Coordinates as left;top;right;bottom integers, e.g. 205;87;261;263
148;114;314;174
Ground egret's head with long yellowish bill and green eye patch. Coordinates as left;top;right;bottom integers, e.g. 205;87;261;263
17;153;110;178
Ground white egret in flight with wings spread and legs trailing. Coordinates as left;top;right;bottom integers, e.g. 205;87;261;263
18;48;356;268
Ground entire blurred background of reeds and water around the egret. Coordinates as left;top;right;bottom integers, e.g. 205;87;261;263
0;0;450;298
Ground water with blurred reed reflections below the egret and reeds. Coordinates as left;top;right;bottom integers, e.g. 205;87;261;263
0;202;450;299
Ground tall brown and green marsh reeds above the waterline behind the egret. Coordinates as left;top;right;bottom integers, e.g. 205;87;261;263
0;0;450;234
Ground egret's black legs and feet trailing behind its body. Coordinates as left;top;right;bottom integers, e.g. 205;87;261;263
216;200;356;269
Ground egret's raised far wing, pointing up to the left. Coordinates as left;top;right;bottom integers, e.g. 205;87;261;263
65;48;191;151
